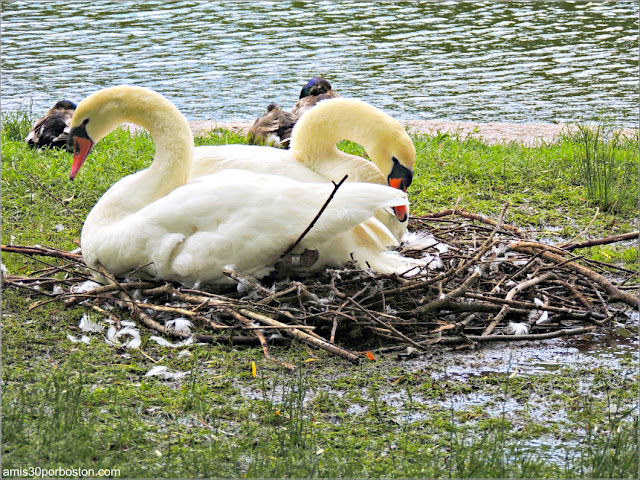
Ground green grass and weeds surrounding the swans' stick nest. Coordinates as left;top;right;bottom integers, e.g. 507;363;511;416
2;116;638;478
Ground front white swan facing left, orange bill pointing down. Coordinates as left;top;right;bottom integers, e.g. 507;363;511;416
68;85;411;286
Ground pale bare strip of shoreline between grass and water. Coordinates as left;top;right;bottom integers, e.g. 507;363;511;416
189;120;638;146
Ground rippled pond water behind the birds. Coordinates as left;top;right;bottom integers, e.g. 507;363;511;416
2;0;638;126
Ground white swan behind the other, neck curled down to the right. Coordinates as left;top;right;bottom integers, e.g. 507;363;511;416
189;98;416;243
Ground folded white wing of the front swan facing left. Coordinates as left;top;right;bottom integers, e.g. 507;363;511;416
82;170;406;284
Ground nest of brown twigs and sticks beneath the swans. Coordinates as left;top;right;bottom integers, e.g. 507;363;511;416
2;206;638;369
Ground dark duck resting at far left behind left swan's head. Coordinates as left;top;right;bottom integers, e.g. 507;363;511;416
25;100;76;148
